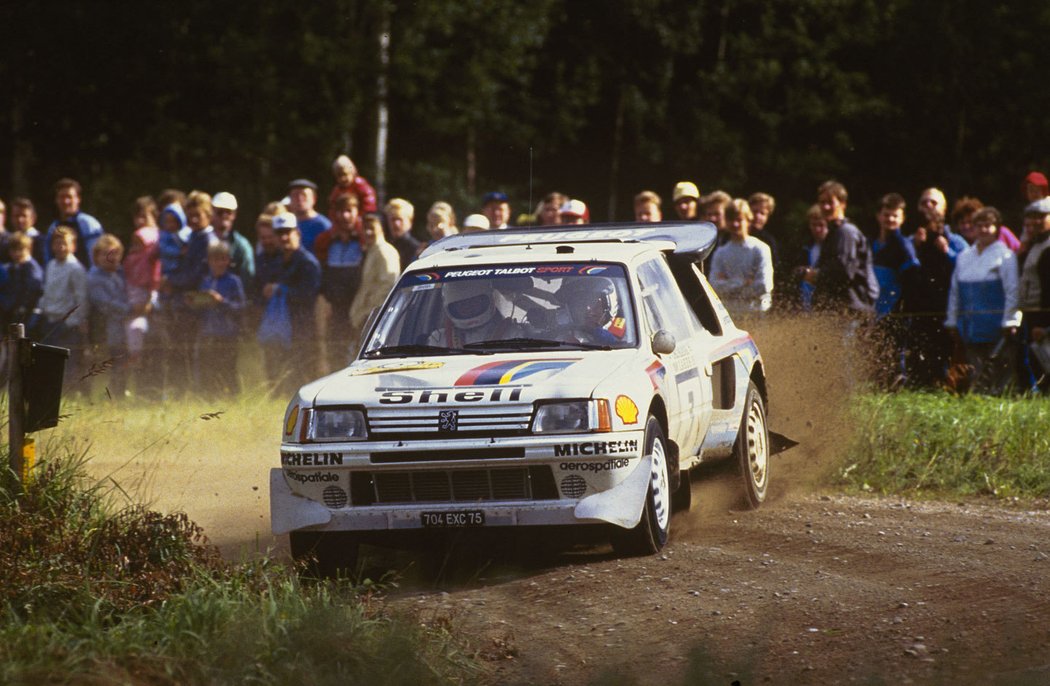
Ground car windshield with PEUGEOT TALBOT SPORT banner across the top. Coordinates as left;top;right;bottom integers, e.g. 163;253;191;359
362;263;637;358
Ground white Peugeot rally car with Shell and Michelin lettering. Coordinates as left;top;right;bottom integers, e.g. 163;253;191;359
270;223;770;568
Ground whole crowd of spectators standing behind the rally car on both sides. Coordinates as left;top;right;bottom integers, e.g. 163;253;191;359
0;155;1050;399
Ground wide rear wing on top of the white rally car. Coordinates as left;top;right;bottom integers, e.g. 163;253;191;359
419;222;718;261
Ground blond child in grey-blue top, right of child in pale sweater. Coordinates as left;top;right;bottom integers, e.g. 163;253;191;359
87;233;131;398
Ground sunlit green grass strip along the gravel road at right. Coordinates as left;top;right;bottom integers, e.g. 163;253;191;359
834;392;1050;500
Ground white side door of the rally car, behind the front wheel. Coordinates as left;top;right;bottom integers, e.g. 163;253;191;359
637;255;711;457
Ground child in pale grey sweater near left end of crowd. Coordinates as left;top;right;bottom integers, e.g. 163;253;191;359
38;224;88;384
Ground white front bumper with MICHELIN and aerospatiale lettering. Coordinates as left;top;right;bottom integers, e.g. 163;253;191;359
270;432;652;535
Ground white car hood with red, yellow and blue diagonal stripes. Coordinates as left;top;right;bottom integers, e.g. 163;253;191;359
300;350;638;406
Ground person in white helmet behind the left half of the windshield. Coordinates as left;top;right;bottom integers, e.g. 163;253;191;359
427;279;522;348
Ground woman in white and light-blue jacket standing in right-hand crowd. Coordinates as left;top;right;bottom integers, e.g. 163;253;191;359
944;207;1021;394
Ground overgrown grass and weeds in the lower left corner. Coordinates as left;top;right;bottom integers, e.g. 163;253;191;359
0;451;481;684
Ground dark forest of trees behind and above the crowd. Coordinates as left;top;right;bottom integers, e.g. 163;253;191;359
0;0;1050;254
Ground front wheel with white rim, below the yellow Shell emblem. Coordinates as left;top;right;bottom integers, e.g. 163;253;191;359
612;416;671;556
